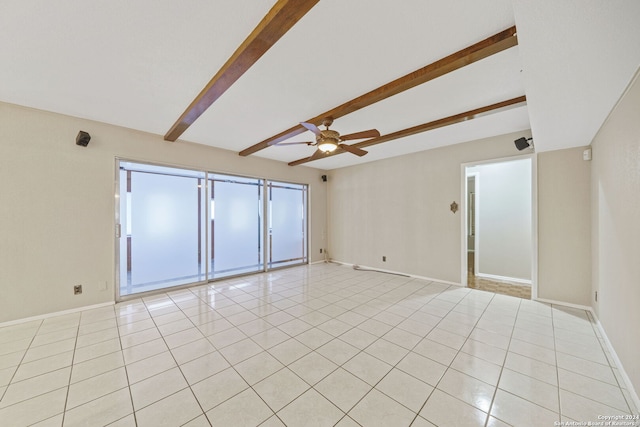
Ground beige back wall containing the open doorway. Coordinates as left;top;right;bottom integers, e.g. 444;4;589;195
327;128;592;304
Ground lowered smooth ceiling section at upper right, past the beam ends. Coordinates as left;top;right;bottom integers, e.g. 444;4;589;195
513;0;640;151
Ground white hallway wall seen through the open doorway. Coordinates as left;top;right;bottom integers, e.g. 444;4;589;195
472;159;532;283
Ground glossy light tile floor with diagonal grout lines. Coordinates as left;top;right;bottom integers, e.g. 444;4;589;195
0;264;638;427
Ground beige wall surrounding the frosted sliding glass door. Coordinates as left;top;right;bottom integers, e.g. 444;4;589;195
0;103;326;323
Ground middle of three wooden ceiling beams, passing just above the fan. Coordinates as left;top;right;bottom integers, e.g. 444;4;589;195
239;26;518;156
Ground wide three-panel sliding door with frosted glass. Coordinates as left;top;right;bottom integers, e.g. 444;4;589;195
116;161;308;298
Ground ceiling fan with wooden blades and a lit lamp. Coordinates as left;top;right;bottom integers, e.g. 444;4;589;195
273;117;380;160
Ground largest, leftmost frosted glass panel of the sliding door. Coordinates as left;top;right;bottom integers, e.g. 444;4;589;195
120;166;206;295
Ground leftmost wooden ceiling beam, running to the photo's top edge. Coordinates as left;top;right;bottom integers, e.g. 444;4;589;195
164;0;320;141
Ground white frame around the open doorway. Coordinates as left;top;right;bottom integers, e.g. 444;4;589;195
460;153;538;300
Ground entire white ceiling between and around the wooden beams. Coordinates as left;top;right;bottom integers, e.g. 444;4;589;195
0;0;640;169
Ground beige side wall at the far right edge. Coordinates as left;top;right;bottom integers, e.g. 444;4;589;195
591;69;640;390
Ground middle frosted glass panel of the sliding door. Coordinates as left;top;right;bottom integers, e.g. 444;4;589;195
210;175;262;277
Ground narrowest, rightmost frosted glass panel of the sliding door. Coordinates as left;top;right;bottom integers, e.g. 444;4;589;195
269;182;307;267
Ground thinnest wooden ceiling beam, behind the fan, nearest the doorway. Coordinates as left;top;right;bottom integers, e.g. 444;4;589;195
289;96;527;166
